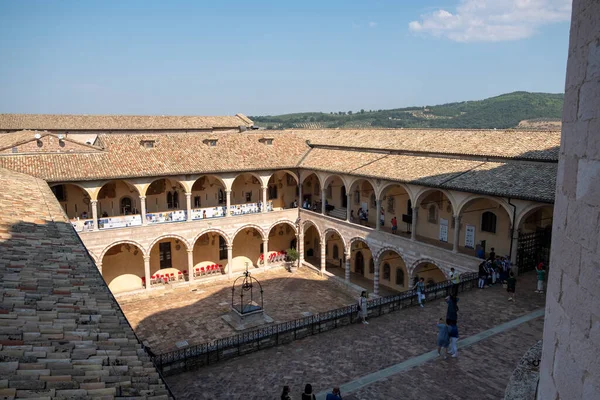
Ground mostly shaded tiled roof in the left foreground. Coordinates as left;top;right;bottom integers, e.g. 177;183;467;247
0;168;167;399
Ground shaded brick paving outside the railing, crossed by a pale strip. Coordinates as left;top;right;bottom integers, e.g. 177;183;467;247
167;274;544;399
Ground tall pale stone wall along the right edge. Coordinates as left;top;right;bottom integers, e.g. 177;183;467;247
538;0;600;400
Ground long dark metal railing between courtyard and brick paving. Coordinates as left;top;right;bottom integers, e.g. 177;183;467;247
154;273;477;375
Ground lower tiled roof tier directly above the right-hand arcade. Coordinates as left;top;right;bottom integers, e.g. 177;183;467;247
300;148;558;203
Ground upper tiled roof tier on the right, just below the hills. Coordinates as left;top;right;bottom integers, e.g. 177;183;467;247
289;129;560;161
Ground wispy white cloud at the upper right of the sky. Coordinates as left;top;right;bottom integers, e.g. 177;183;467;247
408;0;571;42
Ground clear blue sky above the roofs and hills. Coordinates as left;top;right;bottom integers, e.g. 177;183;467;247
0;0;569;115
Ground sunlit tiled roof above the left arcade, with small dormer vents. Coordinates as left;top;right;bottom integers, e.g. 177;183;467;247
0;132;308;181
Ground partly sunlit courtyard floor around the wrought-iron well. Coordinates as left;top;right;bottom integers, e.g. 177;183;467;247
118;267;355;354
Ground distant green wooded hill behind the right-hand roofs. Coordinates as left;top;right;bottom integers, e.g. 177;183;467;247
250;92;564;129
